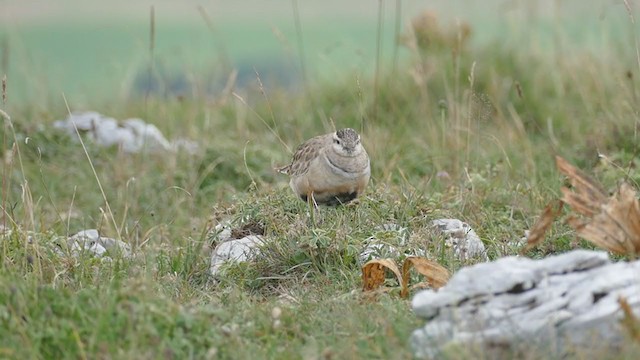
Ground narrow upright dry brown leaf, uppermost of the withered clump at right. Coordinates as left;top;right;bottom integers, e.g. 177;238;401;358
556;156;607;217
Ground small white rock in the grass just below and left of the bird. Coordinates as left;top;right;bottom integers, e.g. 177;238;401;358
210;235;264;275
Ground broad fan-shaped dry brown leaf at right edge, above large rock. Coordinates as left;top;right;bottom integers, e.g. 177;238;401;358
569;183;640;254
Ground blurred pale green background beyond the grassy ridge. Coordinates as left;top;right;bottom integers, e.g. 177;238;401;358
0;0;640;105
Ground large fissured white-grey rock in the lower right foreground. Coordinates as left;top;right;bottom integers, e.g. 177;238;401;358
411;250;640;358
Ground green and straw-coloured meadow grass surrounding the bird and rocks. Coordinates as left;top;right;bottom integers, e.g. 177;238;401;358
0;1;640;359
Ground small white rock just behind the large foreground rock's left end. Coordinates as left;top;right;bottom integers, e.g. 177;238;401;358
432;219;489;261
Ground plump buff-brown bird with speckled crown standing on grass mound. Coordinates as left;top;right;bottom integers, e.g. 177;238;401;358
276;128;371;208
